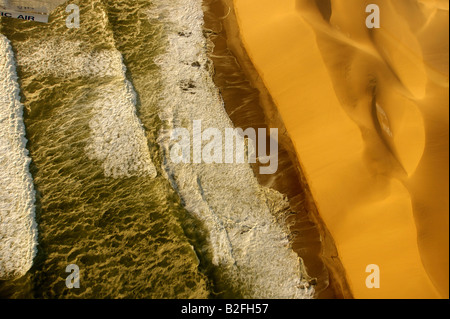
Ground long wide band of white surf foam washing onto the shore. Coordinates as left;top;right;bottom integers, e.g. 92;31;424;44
148;0;314;298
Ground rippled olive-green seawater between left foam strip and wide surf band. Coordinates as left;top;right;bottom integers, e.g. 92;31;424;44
0;0;210;298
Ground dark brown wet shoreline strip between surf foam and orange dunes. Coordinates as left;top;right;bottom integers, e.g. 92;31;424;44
203;0;353;299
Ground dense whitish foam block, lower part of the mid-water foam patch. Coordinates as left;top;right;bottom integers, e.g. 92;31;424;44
86;80;157;178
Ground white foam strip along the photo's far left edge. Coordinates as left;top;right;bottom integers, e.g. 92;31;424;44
0;34;37;279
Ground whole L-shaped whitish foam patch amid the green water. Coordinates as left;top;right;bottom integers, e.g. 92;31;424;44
17;37;157;178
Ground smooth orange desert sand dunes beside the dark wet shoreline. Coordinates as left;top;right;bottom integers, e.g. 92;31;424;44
234;0;449;298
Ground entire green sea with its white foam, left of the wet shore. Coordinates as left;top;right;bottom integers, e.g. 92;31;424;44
0;0;314;298
